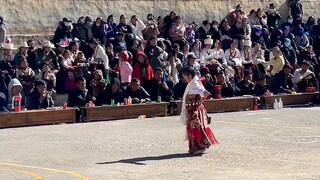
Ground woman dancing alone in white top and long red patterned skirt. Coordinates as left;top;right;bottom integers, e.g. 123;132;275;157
181;68;218;155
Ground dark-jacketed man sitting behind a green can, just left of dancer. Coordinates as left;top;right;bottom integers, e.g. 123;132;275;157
144;68;173;102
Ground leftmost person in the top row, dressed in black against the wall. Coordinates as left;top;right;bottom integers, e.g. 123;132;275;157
52;17;73;44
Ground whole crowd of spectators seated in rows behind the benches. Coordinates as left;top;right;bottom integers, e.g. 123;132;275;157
0;0;320;115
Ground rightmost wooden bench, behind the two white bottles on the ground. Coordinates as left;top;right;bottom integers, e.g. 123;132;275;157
260;92;319;109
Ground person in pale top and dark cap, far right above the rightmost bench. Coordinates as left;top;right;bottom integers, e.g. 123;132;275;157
293;60;318;92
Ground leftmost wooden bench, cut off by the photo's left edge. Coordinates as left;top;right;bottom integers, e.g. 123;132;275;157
0;108;76;128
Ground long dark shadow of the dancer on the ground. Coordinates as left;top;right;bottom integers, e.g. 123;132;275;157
97;153;195;165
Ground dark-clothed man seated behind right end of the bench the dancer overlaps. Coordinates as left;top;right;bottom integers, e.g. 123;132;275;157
237;70;254;96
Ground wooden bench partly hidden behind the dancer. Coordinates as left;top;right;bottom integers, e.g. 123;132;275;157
171;97;254;115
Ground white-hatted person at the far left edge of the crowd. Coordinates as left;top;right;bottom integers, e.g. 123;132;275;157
0;39;15;79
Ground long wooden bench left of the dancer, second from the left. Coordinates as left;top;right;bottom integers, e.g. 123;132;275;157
81;102;168;122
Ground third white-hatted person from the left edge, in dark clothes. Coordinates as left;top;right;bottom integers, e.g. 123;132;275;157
35;41;60;73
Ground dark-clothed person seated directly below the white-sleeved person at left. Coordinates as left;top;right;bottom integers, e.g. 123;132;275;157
90;69;106;99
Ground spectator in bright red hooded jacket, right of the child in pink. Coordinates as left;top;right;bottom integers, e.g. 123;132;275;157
132;52;153;85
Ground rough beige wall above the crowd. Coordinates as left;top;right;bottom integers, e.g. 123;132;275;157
0;0;320;34
